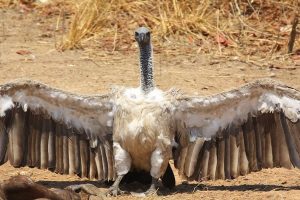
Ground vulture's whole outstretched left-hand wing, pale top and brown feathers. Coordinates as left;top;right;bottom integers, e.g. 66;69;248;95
0;81;115;180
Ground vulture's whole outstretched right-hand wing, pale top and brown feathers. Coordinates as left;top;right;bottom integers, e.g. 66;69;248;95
174;80;300;181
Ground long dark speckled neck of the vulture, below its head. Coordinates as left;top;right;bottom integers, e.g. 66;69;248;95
139;43;154;93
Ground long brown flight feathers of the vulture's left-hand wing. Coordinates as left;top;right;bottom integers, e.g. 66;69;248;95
0;108;115;180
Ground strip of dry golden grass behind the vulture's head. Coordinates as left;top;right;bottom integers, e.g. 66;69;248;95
61;0;300;56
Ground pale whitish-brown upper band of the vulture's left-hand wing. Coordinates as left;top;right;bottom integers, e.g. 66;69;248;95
0;81;113;139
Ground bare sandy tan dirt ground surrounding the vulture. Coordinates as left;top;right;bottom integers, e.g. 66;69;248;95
0;9;300;200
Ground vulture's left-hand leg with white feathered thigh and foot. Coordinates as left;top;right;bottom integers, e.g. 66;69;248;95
107;142;131;196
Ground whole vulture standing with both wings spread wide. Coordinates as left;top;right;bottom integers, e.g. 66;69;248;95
0;27;300;196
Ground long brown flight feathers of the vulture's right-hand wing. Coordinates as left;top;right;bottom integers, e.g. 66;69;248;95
176;113;300;181
